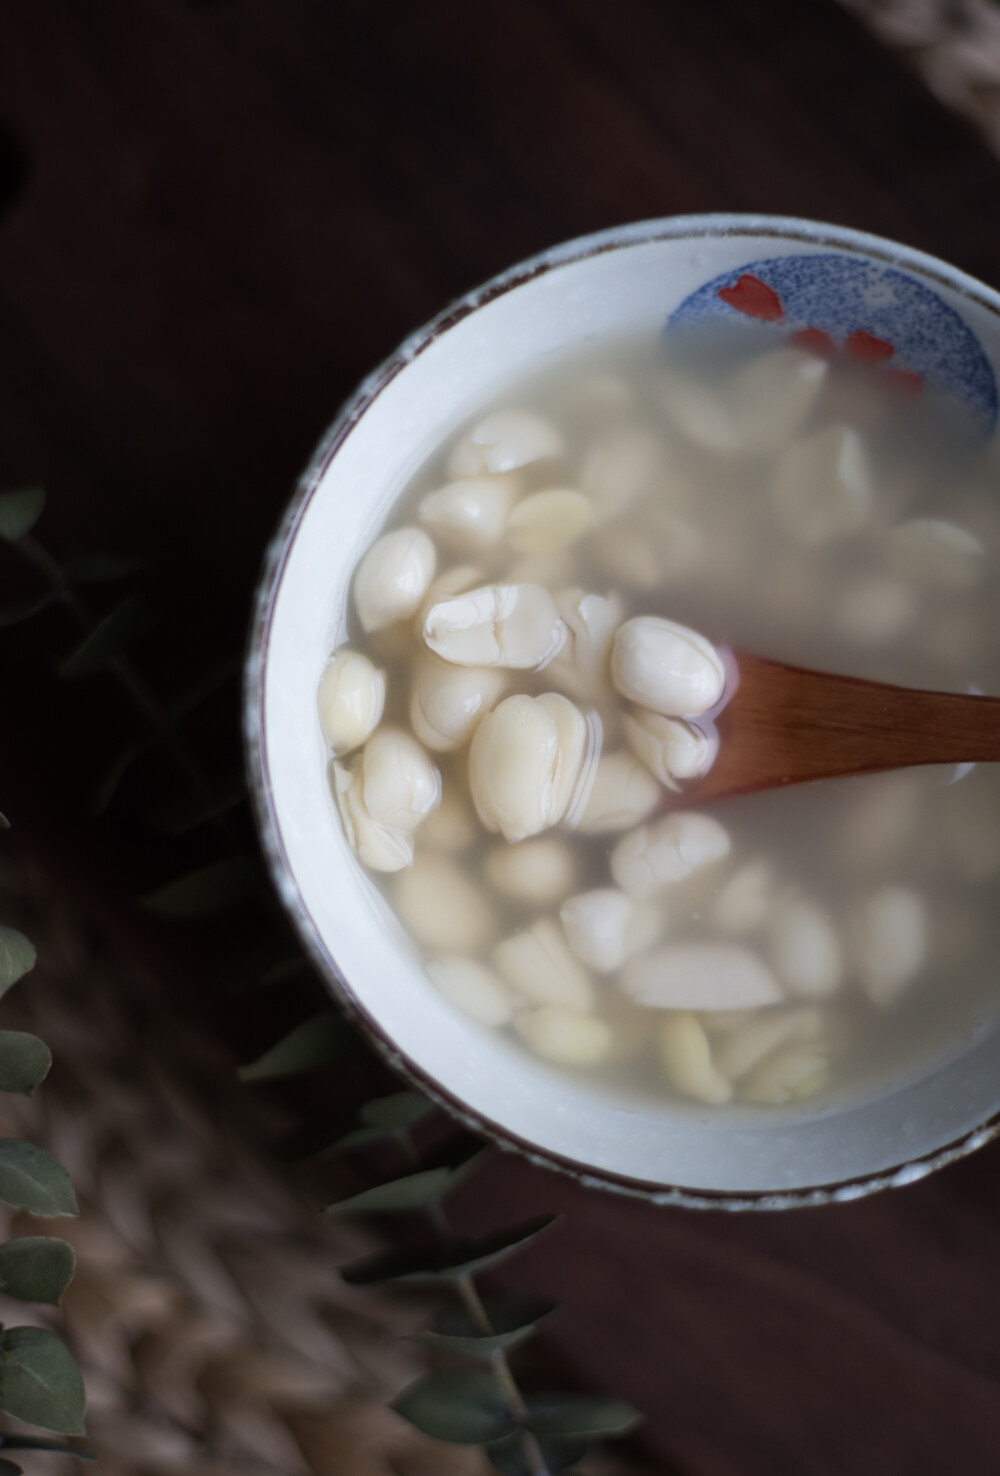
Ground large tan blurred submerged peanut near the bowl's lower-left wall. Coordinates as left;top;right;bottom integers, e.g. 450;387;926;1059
394;850;497;953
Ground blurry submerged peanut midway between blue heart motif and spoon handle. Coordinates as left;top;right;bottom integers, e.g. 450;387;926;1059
771;425;873;548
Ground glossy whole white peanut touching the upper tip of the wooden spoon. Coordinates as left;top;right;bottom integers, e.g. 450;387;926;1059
611;615;726;717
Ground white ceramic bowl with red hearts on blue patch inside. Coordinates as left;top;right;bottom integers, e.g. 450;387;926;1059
246;215;1000;1209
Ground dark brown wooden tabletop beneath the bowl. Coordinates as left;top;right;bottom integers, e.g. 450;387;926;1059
0;0;1000;1476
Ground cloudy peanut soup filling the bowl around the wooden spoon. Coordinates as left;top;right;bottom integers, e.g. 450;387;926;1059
320;329;1000;1114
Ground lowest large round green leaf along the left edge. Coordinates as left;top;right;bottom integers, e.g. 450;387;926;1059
0;1327;87;1435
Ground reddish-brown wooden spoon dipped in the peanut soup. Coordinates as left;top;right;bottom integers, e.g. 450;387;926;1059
683;651;1000;804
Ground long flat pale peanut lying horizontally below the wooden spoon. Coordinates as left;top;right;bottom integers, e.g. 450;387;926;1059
621;943;782;1010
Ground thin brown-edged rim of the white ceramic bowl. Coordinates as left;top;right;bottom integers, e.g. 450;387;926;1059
243;213;1000;1210
